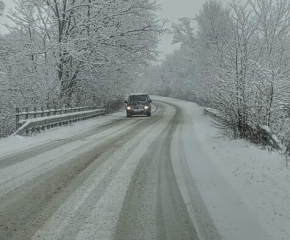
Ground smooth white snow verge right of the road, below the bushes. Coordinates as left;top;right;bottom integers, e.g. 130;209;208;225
157;97;290;240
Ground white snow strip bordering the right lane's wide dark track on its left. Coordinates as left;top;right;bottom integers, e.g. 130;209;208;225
71;102;174;240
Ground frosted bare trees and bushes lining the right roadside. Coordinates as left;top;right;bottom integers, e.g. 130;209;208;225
136;0;290;150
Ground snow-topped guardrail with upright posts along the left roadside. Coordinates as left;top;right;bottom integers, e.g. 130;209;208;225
13;107;105;135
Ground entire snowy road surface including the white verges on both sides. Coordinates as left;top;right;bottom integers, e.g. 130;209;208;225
0;97;289;240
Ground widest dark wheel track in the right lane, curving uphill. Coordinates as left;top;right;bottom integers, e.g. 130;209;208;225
114;102;198;240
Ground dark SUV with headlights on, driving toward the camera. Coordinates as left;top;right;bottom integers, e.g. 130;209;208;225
125;93;152;117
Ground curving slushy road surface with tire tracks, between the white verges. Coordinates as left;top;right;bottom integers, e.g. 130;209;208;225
0;102;215;240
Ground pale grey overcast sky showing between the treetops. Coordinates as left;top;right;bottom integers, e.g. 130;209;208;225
0;0;230;58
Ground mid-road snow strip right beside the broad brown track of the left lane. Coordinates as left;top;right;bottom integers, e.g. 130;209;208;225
33;102;167;240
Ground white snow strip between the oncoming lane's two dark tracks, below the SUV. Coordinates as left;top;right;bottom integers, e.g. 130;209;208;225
0;116;137;197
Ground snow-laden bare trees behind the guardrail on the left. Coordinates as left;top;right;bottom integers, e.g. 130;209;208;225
0;0;163;137
